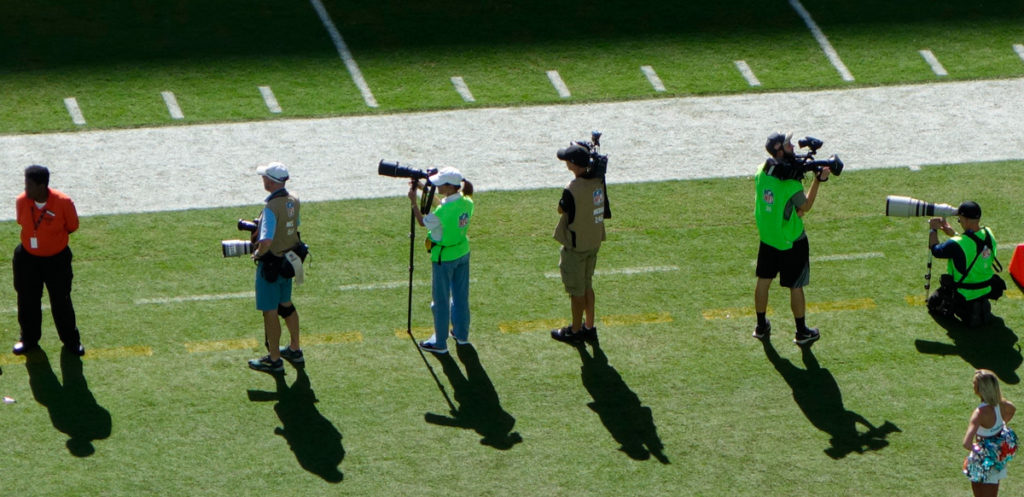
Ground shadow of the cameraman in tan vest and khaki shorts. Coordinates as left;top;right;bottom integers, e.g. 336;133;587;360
577;340;670;464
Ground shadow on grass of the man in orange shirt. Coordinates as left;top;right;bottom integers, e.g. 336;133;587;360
25;347;112;457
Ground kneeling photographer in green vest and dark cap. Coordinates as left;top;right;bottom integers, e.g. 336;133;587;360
928;201;1006;328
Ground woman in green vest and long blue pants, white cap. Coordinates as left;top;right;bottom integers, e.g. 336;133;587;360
409;167;473;354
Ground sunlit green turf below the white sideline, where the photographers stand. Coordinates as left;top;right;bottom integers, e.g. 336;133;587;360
0;162;1024;496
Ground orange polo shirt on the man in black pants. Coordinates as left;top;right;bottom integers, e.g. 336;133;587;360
14;189;78;257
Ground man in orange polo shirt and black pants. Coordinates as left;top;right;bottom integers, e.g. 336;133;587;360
13;165;85;356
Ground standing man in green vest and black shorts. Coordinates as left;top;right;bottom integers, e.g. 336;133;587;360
754;133;830;345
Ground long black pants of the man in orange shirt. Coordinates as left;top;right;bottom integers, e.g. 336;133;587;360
13;245;81;347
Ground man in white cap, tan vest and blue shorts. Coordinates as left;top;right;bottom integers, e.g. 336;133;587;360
249;162;305;373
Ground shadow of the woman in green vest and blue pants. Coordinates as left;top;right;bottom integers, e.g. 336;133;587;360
424;343;522;450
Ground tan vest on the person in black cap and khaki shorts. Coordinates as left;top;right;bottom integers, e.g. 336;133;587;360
554;177;606;252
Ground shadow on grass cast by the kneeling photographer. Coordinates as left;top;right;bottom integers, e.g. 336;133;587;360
913;315;1024;384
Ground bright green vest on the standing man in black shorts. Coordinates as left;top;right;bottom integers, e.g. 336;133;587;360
754;162;804;250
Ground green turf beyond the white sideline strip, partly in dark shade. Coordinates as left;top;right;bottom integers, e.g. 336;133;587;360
0;0;1024;133
